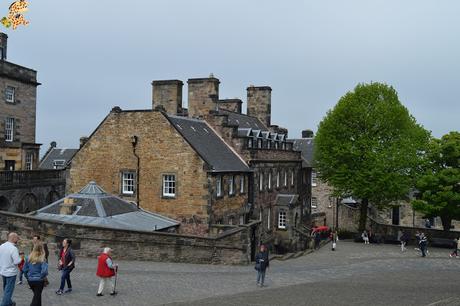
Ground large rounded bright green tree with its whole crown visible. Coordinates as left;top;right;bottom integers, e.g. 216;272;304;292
314;83;429;230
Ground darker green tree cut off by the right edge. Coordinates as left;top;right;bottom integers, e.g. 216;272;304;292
412;132;460;231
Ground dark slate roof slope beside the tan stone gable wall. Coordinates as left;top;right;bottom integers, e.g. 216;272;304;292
166;115;250;172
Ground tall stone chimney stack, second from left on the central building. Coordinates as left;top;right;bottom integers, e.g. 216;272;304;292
187;74;220;117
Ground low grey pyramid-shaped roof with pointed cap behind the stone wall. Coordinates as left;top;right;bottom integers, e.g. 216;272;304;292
34;182;179;232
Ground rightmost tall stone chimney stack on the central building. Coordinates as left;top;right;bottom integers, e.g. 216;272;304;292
247;86;272;128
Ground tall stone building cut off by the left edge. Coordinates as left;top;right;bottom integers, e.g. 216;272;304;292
0;33;40;170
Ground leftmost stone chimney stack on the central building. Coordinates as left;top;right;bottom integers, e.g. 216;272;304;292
152;80;184;115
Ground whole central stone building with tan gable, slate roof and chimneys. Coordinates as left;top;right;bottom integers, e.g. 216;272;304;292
68;77;310;255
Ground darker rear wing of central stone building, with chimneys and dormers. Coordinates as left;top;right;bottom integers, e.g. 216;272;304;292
152;76;310;252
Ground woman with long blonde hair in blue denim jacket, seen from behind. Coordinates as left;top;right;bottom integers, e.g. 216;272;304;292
24;242;48;306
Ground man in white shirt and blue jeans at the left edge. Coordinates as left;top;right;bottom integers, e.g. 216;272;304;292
0;233;21;306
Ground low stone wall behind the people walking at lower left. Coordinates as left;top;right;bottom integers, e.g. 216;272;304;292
0;211;251;264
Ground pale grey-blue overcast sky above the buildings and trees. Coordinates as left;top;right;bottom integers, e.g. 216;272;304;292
4;0;460;154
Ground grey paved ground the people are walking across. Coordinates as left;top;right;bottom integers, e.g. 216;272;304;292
4;241;460;306
